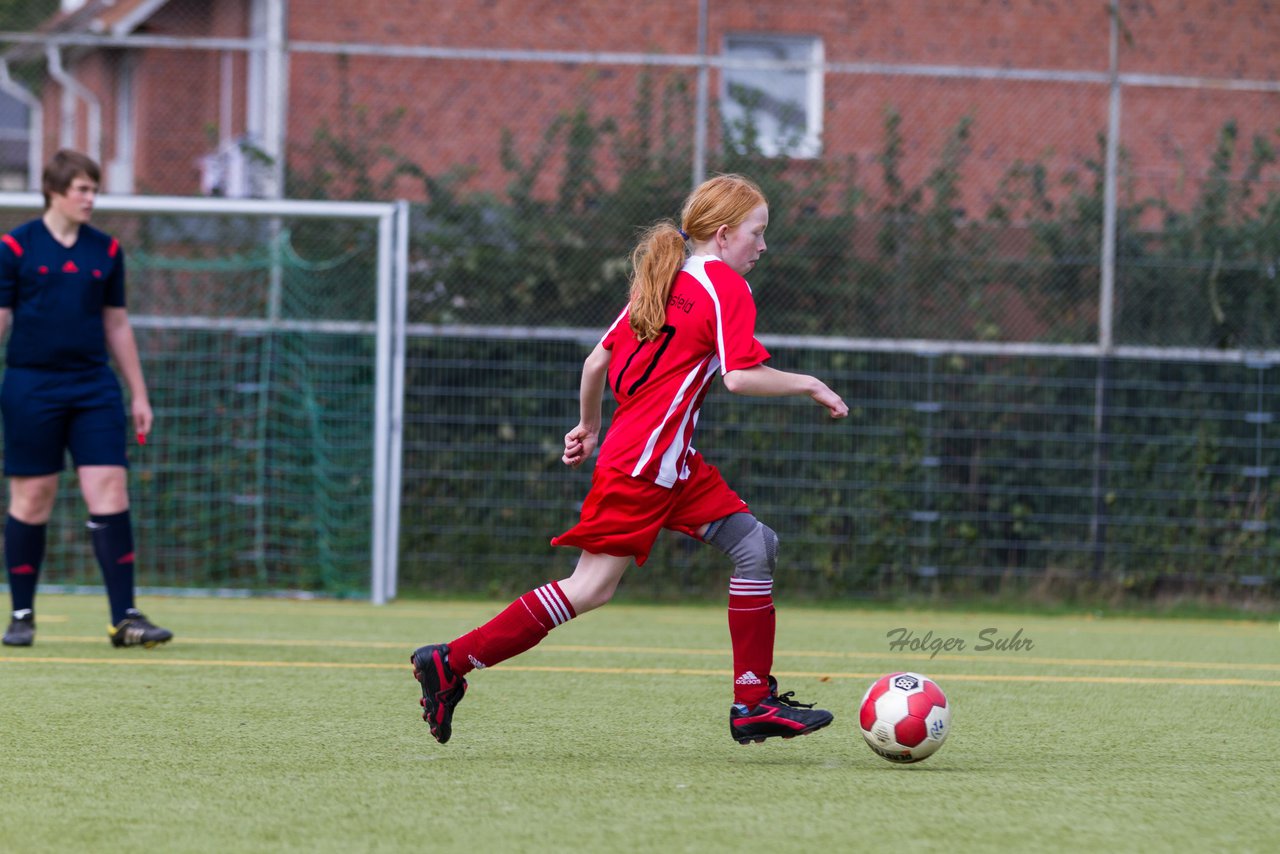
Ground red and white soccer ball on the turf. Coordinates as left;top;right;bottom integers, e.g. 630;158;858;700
858;673;951;764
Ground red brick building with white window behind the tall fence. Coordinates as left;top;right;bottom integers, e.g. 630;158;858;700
8;0;1280;212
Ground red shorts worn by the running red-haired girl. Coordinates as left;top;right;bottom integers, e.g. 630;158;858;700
552;453;750;566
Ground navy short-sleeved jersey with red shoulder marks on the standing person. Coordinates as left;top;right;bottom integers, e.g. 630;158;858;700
0;219;124;370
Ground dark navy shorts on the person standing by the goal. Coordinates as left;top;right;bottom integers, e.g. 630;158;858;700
0;365;129;478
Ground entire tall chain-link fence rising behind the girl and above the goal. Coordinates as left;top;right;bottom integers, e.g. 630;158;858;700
0;0;1280;601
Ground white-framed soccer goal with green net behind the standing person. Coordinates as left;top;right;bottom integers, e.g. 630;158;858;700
0;193;408;603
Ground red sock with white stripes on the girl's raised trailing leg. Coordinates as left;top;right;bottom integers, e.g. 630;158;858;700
449;581;577;676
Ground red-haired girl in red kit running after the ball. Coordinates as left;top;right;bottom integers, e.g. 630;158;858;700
410;175;849;744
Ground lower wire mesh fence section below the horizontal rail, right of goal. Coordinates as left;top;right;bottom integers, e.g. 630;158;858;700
401;330;1280;598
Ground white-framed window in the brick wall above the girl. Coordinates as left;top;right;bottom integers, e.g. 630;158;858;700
721;33;823;157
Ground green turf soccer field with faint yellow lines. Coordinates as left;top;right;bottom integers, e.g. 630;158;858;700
0;595;1280;854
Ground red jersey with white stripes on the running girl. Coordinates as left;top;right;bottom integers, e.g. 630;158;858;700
596;255;769;488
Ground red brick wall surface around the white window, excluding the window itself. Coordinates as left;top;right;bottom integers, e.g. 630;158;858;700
47;0;1280;209
